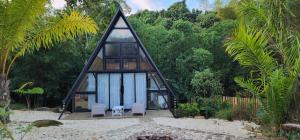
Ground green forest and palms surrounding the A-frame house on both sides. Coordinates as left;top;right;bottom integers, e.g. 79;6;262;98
0;0;300;137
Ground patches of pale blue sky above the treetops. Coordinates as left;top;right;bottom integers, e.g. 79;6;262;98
51;0;219;14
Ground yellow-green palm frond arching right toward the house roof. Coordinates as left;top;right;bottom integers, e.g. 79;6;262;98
18;11;98;56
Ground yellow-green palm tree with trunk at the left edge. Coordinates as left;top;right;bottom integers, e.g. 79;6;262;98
0;0;97;113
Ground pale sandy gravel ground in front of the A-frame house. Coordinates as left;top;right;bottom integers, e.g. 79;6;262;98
10;110;257;140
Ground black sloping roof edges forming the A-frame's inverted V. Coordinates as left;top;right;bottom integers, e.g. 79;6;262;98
59;9;176;118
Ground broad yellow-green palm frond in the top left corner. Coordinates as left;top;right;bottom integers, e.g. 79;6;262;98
3;0;47;50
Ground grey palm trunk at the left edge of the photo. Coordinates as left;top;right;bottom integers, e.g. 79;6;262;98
0;75;10;123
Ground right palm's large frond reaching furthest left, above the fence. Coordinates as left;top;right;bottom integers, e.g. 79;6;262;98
225;24;276;73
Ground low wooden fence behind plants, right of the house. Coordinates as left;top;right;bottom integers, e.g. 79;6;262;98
222;96;259;108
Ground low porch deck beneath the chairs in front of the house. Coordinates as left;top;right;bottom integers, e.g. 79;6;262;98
62;110;173;120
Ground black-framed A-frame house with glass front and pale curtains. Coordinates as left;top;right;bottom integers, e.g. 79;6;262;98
59;9;176;118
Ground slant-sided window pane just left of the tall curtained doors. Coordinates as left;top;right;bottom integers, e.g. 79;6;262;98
77;73;96;92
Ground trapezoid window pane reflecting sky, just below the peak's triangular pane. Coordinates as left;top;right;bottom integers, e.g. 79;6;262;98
106;29;135;42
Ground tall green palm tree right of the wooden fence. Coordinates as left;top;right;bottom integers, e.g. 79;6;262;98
226;0;300;127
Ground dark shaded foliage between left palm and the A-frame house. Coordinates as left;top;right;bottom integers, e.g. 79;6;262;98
12;41;87;107
